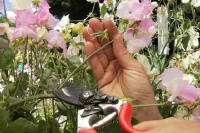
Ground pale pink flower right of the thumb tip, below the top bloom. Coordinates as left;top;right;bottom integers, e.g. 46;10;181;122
123;19;156;53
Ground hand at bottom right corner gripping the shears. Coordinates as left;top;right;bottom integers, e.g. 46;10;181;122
134;118;200;133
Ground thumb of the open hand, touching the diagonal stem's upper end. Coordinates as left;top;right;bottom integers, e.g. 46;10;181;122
113;34;136;68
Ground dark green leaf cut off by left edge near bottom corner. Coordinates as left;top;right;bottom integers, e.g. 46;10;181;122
0;109;10;133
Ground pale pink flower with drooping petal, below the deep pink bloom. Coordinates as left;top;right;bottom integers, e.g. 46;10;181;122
46;30;66;57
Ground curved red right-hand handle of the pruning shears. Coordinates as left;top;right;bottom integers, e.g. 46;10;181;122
119;103;141;133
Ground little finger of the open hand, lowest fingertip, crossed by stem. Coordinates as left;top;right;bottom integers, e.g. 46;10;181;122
84;42;104;81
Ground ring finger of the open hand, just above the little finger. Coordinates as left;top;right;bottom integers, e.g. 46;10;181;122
83;27;108;68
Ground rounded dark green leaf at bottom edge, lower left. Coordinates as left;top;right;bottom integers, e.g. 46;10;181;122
6;118;39;133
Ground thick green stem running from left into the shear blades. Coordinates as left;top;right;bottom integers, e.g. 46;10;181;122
8;94;55;108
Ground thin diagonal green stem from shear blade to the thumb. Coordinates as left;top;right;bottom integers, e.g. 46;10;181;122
57;40;113;89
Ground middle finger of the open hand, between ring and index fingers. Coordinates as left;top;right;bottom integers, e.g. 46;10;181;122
89;18;114;60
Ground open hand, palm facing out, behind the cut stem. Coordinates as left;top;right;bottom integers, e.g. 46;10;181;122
83;18;161;121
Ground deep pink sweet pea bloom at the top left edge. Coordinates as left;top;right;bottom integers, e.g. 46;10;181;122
36;0;57;28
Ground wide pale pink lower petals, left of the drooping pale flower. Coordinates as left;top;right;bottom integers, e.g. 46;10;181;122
10;26;37;40
